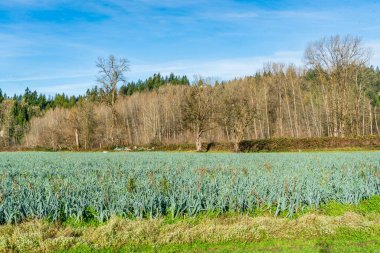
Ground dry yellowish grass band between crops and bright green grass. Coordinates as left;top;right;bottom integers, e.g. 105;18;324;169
0;212;380;252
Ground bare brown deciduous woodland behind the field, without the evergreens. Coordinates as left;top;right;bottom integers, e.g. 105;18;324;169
25;65;380;149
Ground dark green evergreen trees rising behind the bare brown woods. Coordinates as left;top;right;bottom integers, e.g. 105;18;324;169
0;70;190;148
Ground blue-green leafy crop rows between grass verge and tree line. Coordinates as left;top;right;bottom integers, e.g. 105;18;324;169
0;152;380;223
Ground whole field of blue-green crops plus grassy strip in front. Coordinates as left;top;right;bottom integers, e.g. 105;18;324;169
0;152;380;252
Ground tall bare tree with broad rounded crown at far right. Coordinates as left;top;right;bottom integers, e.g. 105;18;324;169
305;35;371;136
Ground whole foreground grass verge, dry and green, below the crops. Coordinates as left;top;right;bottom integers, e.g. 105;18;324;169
0;211;380;252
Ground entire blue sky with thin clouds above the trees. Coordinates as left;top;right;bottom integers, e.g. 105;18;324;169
0;0;380;94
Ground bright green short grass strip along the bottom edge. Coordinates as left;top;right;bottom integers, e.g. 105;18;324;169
57;233;380;253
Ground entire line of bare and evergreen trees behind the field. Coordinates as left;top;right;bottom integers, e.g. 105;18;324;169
0;35;380;151
